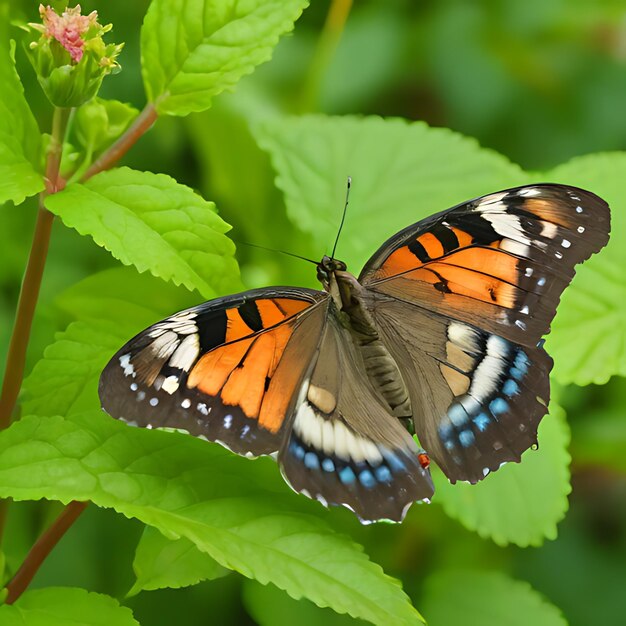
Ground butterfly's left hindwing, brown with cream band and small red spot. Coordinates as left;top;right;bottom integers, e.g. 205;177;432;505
278;311;434;522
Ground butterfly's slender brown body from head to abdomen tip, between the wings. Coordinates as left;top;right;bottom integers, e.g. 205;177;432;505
318;256;412;418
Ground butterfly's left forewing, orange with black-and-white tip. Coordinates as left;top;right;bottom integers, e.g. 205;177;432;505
99;287;328;456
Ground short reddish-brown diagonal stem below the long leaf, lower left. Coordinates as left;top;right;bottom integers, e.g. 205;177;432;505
5;501;88;604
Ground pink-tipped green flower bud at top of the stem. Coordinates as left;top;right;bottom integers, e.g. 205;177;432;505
29;4;123;107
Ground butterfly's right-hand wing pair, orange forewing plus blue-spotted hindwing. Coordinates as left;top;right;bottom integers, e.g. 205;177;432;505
360;185;610;482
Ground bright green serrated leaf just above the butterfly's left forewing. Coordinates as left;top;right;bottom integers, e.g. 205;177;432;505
46;167;239;298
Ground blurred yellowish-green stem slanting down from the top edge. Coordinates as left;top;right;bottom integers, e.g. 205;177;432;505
299;0;352;113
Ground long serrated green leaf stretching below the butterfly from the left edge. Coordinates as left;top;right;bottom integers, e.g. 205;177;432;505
0;412;421;624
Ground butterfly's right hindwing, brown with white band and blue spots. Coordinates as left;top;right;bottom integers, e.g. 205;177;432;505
374;300;552;483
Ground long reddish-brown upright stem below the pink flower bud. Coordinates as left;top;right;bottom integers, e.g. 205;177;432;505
0;108;70;430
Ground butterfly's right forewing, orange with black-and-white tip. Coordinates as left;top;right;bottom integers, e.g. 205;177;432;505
359;184;610;346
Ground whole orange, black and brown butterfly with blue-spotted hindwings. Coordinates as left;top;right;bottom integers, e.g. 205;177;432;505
99;184;610;522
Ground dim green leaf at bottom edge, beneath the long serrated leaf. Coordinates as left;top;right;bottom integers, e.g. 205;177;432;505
243;580;365;626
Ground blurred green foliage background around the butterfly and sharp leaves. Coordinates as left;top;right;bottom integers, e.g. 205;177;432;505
0;0;626;626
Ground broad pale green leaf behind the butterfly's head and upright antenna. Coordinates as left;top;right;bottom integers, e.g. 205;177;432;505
254;115;529;272
